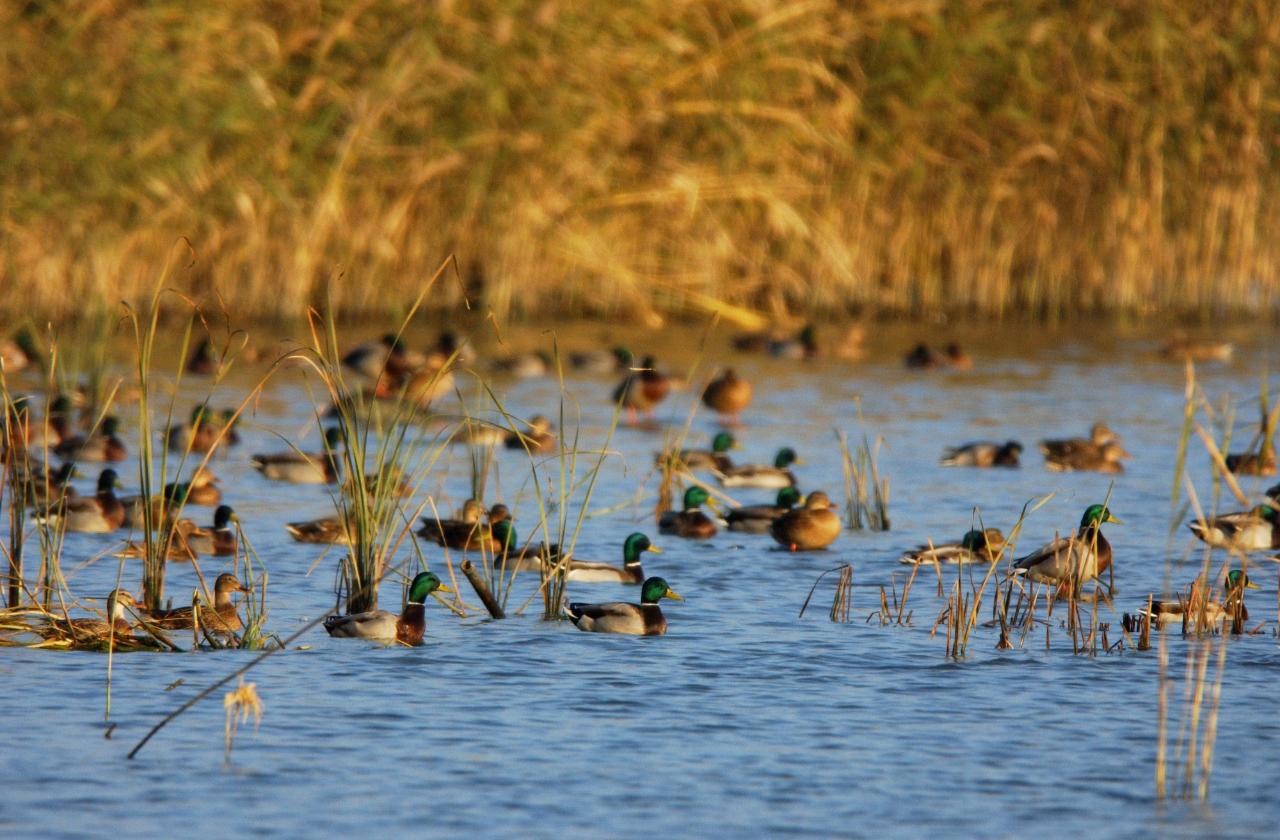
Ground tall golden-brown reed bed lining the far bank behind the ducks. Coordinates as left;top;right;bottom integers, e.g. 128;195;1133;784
0;0;1280;323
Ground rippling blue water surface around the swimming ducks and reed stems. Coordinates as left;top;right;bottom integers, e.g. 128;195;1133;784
0;330;1280;837
